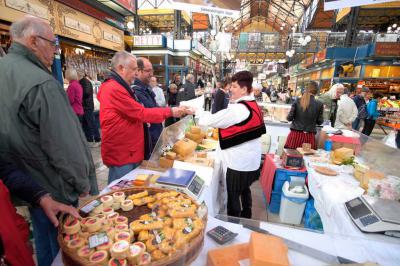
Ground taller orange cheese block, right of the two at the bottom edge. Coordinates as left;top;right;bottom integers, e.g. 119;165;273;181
249;232;290;266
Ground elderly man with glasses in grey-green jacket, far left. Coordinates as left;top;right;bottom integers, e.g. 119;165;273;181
0;16;98;265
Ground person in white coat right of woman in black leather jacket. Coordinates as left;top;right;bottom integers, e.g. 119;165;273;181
335;88;358;129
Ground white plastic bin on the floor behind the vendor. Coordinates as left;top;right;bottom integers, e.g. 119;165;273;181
279;182;309;224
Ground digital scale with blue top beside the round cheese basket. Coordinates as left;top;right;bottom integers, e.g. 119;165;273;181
155;168;205;200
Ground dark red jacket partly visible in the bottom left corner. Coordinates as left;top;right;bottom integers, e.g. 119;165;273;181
0;180;35;266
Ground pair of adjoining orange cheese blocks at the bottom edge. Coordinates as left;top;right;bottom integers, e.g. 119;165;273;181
207;232;290;266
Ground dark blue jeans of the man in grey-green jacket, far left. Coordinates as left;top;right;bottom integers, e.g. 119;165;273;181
29;207;60;266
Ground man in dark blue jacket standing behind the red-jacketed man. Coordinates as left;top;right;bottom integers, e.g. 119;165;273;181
134;57;163;156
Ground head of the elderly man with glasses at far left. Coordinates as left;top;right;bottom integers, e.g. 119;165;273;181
10;16;56;67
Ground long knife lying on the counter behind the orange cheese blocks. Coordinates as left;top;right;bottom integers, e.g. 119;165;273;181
242;224;357;264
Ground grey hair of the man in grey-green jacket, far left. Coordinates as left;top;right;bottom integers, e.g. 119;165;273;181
10;15;50;40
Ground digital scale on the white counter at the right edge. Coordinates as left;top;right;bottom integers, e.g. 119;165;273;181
345;193;400;237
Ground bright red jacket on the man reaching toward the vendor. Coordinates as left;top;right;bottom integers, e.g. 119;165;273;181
97;79;172;166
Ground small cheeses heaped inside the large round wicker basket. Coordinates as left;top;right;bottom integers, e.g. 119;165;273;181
63;190;204;265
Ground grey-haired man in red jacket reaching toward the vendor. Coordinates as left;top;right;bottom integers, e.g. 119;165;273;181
97;51;190;183
